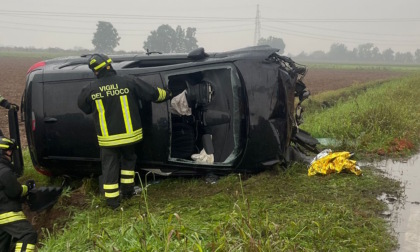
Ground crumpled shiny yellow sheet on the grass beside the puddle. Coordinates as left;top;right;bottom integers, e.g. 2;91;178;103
308;150;362;176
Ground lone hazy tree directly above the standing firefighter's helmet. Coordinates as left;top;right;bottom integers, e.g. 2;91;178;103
92;21;121;53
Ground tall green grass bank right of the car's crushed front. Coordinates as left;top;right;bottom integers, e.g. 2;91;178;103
302;75;420;153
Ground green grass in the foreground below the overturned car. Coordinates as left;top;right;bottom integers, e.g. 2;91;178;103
39;164;399;251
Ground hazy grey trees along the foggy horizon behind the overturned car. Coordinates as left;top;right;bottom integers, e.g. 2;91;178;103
0;21;420;64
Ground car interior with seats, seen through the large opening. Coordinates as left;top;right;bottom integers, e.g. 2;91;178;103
167;68;240;165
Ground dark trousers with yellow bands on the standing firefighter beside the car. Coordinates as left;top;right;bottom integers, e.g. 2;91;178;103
101;145;137;208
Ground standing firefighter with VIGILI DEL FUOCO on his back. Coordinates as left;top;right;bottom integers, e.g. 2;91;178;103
78;54;171;209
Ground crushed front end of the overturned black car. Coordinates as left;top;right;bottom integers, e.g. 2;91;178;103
231;48;318;170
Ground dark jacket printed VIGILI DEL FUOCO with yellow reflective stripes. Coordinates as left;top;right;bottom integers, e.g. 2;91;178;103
78;71;170;147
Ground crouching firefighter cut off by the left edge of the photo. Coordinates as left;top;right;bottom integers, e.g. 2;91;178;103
0;137;38;251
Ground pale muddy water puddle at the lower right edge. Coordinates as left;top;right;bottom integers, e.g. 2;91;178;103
374;153;420;251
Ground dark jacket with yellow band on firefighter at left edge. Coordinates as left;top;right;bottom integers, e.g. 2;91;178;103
0;157;28;225
